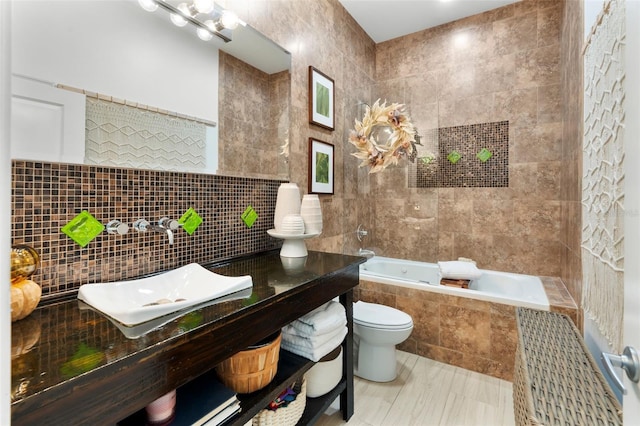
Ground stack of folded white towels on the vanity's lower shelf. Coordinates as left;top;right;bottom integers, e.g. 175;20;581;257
280;300;347;362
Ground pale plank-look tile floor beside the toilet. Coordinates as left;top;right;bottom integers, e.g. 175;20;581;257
316;351;515;426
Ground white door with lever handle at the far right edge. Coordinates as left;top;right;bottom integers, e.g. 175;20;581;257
623;0;640;425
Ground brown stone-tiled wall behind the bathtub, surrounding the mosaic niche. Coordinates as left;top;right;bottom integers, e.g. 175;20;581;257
359;0;566;276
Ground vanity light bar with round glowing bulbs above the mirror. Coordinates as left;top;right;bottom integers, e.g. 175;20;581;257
138;0;240;43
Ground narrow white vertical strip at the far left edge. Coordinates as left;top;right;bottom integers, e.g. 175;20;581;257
0;1;11;425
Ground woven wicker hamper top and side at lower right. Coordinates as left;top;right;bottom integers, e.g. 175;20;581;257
513;308;622;426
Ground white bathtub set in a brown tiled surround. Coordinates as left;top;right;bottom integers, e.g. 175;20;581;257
360;256;549;311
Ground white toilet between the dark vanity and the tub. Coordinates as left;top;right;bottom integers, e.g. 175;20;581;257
353;301;413;382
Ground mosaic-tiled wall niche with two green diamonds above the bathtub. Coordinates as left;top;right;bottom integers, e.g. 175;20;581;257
409;121;509;188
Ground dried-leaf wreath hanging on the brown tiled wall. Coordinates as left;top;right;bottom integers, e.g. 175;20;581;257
349;99;420;173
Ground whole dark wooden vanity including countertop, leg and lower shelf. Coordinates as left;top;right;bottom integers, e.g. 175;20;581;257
11;251;365;426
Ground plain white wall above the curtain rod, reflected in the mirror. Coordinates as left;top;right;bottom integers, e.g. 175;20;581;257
12;0;218;122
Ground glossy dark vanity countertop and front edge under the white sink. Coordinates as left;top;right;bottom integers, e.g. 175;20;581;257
11;251;365;424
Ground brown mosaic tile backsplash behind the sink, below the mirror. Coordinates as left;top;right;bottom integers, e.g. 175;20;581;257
11;160;282;301
